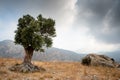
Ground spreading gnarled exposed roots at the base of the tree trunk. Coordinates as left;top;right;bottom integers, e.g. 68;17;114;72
9;63;45;73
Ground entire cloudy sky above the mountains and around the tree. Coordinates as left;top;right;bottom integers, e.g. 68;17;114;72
0;0;120;53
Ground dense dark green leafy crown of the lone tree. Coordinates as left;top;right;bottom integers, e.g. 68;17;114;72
15;15;56;51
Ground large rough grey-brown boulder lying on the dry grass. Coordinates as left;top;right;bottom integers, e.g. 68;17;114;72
82;54;117;68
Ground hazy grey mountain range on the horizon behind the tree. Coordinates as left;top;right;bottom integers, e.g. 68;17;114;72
0;40;85;61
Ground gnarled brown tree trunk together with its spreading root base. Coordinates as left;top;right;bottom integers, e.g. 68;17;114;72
10;46;45;72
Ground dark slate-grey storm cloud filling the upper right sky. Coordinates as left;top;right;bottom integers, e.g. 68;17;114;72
76;0;120;43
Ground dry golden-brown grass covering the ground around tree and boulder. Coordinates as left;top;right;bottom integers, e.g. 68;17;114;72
0;58;120;80
